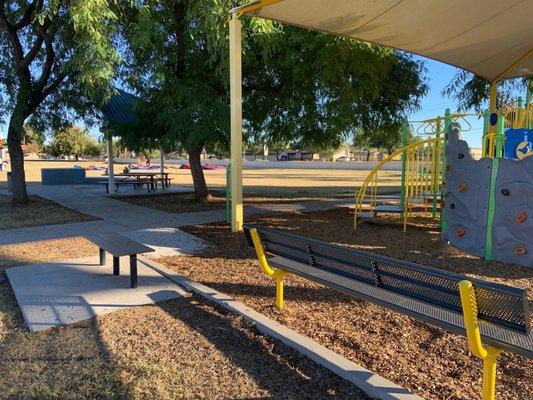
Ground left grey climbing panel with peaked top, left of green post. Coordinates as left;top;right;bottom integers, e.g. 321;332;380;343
442;124;491;257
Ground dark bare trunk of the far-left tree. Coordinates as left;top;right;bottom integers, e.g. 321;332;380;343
7;108;29;205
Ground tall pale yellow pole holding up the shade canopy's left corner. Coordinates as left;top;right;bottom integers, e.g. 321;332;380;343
229;13;244;232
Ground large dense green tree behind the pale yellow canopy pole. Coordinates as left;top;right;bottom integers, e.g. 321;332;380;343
118;0;427;200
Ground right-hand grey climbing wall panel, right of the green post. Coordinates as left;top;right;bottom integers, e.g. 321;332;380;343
492;157;533;266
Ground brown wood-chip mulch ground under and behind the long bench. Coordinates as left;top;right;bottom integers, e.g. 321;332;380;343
159;209;533;400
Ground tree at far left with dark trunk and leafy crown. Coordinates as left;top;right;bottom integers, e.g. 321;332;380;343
0;0;119;204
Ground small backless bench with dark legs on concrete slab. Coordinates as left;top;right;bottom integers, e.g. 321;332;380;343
86;232;155;288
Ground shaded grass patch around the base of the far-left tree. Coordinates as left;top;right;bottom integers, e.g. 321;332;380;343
0;195;98;230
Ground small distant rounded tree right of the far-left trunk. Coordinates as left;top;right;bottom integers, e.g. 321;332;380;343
48;126;100;157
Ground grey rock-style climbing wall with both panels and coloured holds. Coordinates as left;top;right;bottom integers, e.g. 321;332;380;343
442;124;533;267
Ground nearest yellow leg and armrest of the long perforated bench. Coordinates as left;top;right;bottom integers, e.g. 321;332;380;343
459;280;501;400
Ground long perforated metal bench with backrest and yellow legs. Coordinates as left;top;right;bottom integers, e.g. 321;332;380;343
244;225;533;400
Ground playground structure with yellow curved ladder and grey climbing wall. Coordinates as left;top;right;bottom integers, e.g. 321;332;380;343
354;87;533;267
